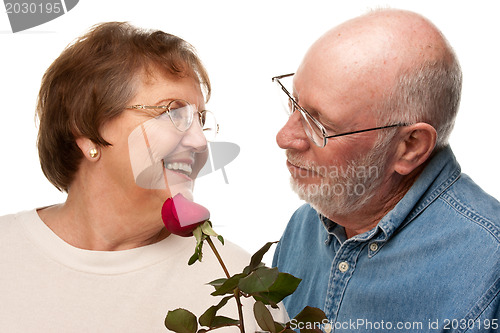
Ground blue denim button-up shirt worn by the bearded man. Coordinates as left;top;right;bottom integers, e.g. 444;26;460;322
273;147;500;332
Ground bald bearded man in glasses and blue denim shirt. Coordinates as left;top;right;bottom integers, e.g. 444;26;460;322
273;10;500;332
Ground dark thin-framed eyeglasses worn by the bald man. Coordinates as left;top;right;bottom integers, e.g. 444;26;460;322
272;73;409;148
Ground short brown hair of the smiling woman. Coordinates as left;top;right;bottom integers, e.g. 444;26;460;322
37;22;211;192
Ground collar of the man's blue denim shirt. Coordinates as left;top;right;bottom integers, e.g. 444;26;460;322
319;146;461;244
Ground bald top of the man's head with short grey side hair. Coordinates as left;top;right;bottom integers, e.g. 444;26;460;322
296;10;461;147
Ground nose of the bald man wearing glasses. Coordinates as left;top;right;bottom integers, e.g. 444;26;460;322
276;111;309;150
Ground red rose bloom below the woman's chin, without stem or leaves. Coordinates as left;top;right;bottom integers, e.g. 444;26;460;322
161;193;210;237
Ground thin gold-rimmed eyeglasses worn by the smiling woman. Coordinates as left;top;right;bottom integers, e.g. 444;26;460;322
127;99;219;141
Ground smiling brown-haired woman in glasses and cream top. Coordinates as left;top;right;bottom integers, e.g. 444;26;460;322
0;23;282;333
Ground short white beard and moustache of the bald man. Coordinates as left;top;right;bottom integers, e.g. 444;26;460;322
289;138;390;216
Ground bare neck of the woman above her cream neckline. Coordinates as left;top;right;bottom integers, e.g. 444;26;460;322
38;180;168;251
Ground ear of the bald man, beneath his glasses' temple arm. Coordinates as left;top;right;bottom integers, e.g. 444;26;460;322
394;123;437;175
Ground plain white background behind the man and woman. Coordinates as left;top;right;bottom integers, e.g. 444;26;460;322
0;0;500;260
